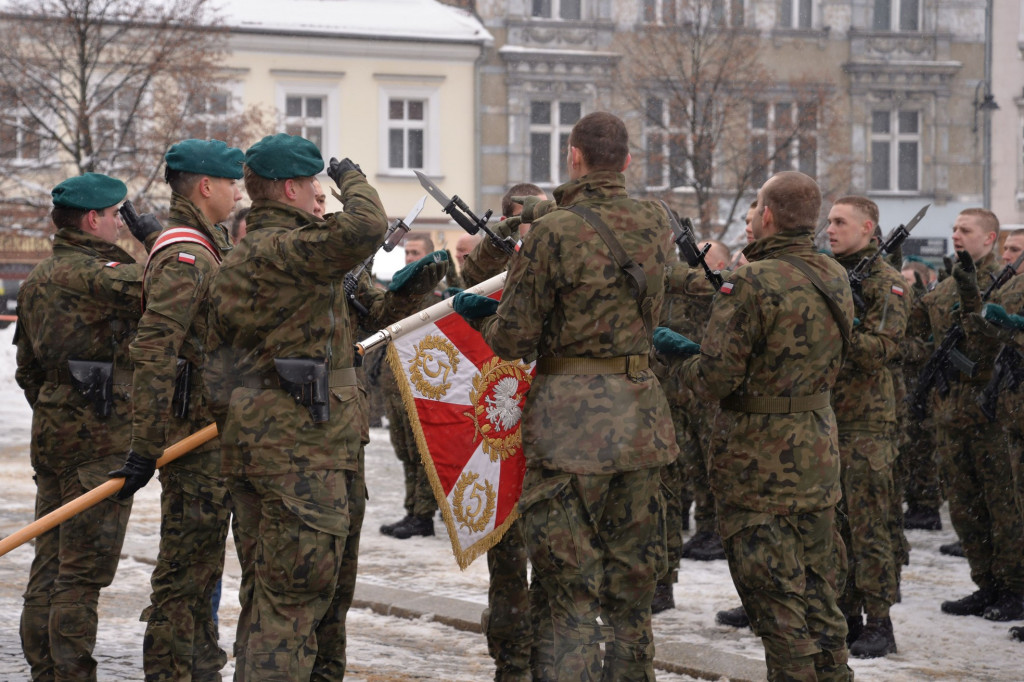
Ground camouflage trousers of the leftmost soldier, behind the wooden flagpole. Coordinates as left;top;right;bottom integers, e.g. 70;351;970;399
20;453;131;682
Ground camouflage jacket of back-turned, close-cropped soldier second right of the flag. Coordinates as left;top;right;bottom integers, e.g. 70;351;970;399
677;232;853;512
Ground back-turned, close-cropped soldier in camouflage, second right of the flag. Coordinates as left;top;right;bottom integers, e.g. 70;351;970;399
655;171;853;682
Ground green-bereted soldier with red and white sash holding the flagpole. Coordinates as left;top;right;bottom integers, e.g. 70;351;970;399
107;139;244;681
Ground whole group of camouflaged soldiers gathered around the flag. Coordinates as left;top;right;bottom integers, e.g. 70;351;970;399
9;113;1024;680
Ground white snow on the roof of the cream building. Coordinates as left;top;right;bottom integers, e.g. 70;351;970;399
214;0;494;44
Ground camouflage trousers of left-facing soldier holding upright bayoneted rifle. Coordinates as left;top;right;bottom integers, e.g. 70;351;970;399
836;427;901;619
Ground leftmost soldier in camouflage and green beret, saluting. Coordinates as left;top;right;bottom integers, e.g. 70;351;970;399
14;173;159;682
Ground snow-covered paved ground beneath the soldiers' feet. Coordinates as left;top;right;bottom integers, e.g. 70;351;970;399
0;319;1024;682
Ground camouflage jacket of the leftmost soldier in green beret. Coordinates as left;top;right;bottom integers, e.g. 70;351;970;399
14;229;142;468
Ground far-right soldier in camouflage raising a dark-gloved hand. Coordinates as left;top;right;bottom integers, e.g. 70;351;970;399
907;209;1024;621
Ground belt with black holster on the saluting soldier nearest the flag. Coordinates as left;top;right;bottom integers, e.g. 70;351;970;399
238;357;358;424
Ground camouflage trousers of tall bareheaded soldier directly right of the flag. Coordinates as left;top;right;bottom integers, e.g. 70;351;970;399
519;468;668;682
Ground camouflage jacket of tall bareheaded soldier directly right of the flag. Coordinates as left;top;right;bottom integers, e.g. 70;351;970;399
480;171;678;474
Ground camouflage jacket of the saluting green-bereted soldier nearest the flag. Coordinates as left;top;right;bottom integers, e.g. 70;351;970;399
204;171;387;476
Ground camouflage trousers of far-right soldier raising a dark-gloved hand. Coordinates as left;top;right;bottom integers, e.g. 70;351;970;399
938;417;1024;594
